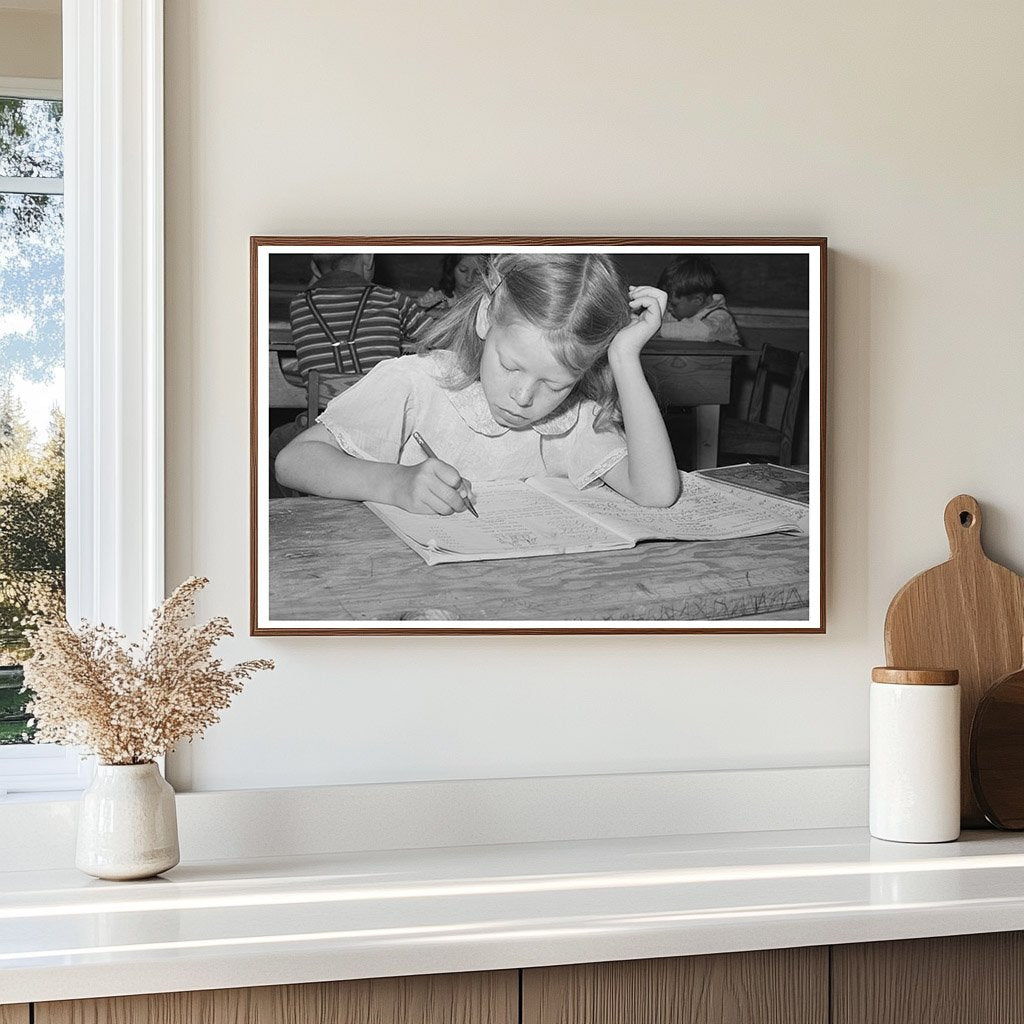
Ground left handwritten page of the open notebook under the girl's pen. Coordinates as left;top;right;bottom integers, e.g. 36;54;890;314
367;480;632;564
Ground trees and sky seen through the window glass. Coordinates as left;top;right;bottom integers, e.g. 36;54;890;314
0;96;65;744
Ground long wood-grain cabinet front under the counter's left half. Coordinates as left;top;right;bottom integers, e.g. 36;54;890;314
35;971;519;1024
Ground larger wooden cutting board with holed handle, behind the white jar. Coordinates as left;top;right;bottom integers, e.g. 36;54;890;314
886;495;1024;828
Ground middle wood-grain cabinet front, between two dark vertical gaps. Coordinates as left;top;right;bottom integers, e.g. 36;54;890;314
522;947;828;1024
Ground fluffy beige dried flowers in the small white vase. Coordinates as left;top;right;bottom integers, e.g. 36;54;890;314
25;577;273;765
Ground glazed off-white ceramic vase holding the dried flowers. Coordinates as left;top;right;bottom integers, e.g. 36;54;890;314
75;761;180;882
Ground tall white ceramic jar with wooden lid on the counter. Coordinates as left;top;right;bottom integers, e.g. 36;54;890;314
869;669;961;843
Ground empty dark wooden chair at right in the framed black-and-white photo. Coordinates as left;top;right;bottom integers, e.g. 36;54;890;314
718;344;807;466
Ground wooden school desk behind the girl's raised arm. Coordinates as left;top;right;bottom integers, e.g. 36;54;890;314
641;338;751;469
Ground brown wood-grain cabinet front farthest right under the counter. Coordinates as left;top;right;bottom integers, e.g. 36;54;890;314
831;932;1024;1024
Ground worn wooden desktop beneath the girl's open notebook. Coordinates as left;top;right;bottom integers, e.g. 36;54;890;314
268;498;809;624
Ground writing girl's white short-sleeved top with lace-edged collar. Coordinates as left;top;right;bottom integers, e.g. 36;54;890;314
316;350;626;487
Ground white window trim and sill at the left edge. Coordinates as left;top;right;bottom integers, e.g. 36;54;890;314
0;0;164;795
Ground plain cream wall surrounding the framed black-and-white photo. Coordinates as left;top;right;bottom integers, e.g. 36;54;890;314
161;0;1024;790
